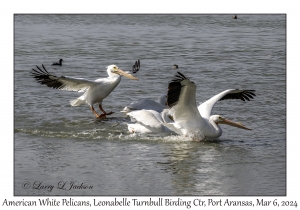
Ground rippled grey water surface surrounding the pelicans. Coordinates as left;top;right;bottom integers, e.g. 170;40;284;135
14;14;286;196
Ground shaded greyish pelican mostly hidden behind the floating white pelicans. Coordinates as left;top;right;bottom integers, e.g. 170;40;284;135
121;95;167;113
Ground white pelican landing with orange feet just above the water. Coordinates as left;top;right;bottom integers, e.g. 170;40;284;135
31;60;140;118
